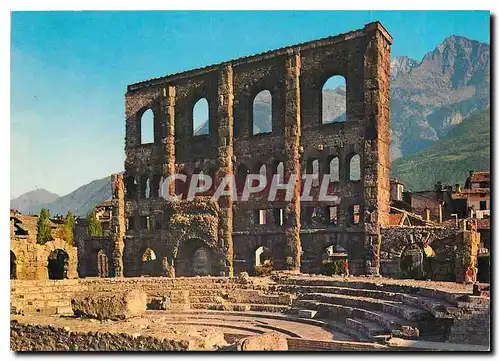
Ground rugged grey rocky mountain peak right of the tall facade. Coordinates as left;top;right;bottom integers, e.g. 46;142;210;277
391;36;490;159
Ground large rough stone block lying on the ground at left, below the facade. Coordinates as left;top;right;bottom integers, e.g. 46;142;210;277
71;290;147;320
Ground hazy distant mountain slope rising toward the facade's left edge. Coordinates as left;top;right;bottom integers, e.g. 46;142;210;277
22;177;111;217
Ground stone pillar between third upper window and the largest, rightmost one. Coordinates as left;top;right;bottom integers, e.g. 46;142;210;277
284;52;302;272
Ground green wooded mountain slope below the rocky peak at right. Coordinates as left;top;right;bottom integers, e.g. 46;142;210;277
392;109;490;191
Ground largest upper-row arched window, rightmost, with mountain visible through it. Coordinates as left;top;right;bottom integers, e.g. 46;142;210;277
321;75;347;124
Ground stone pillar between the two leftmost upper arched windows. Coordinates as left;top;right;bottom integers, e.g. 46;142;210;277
162;86;175;195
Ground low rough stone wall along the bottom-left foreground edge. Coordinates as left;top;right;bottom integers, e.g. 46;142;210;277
10;321;189;351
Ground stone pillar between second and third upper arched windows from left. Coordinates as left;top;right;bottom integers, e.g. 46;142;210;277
216;64;234;277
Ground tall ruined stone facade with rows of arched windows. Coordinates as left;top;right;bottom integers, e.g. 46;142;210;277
113;22;392;276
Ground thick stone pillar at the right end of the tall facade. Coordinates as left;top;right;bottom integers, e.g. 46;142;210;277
362;22;392;274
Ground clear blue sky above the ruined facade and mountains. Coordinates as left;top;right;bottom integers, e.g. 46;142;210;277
10;11;490;196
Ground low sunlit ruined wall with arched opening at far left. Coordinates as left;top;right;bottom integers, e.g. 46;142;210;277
10;236;78;280
